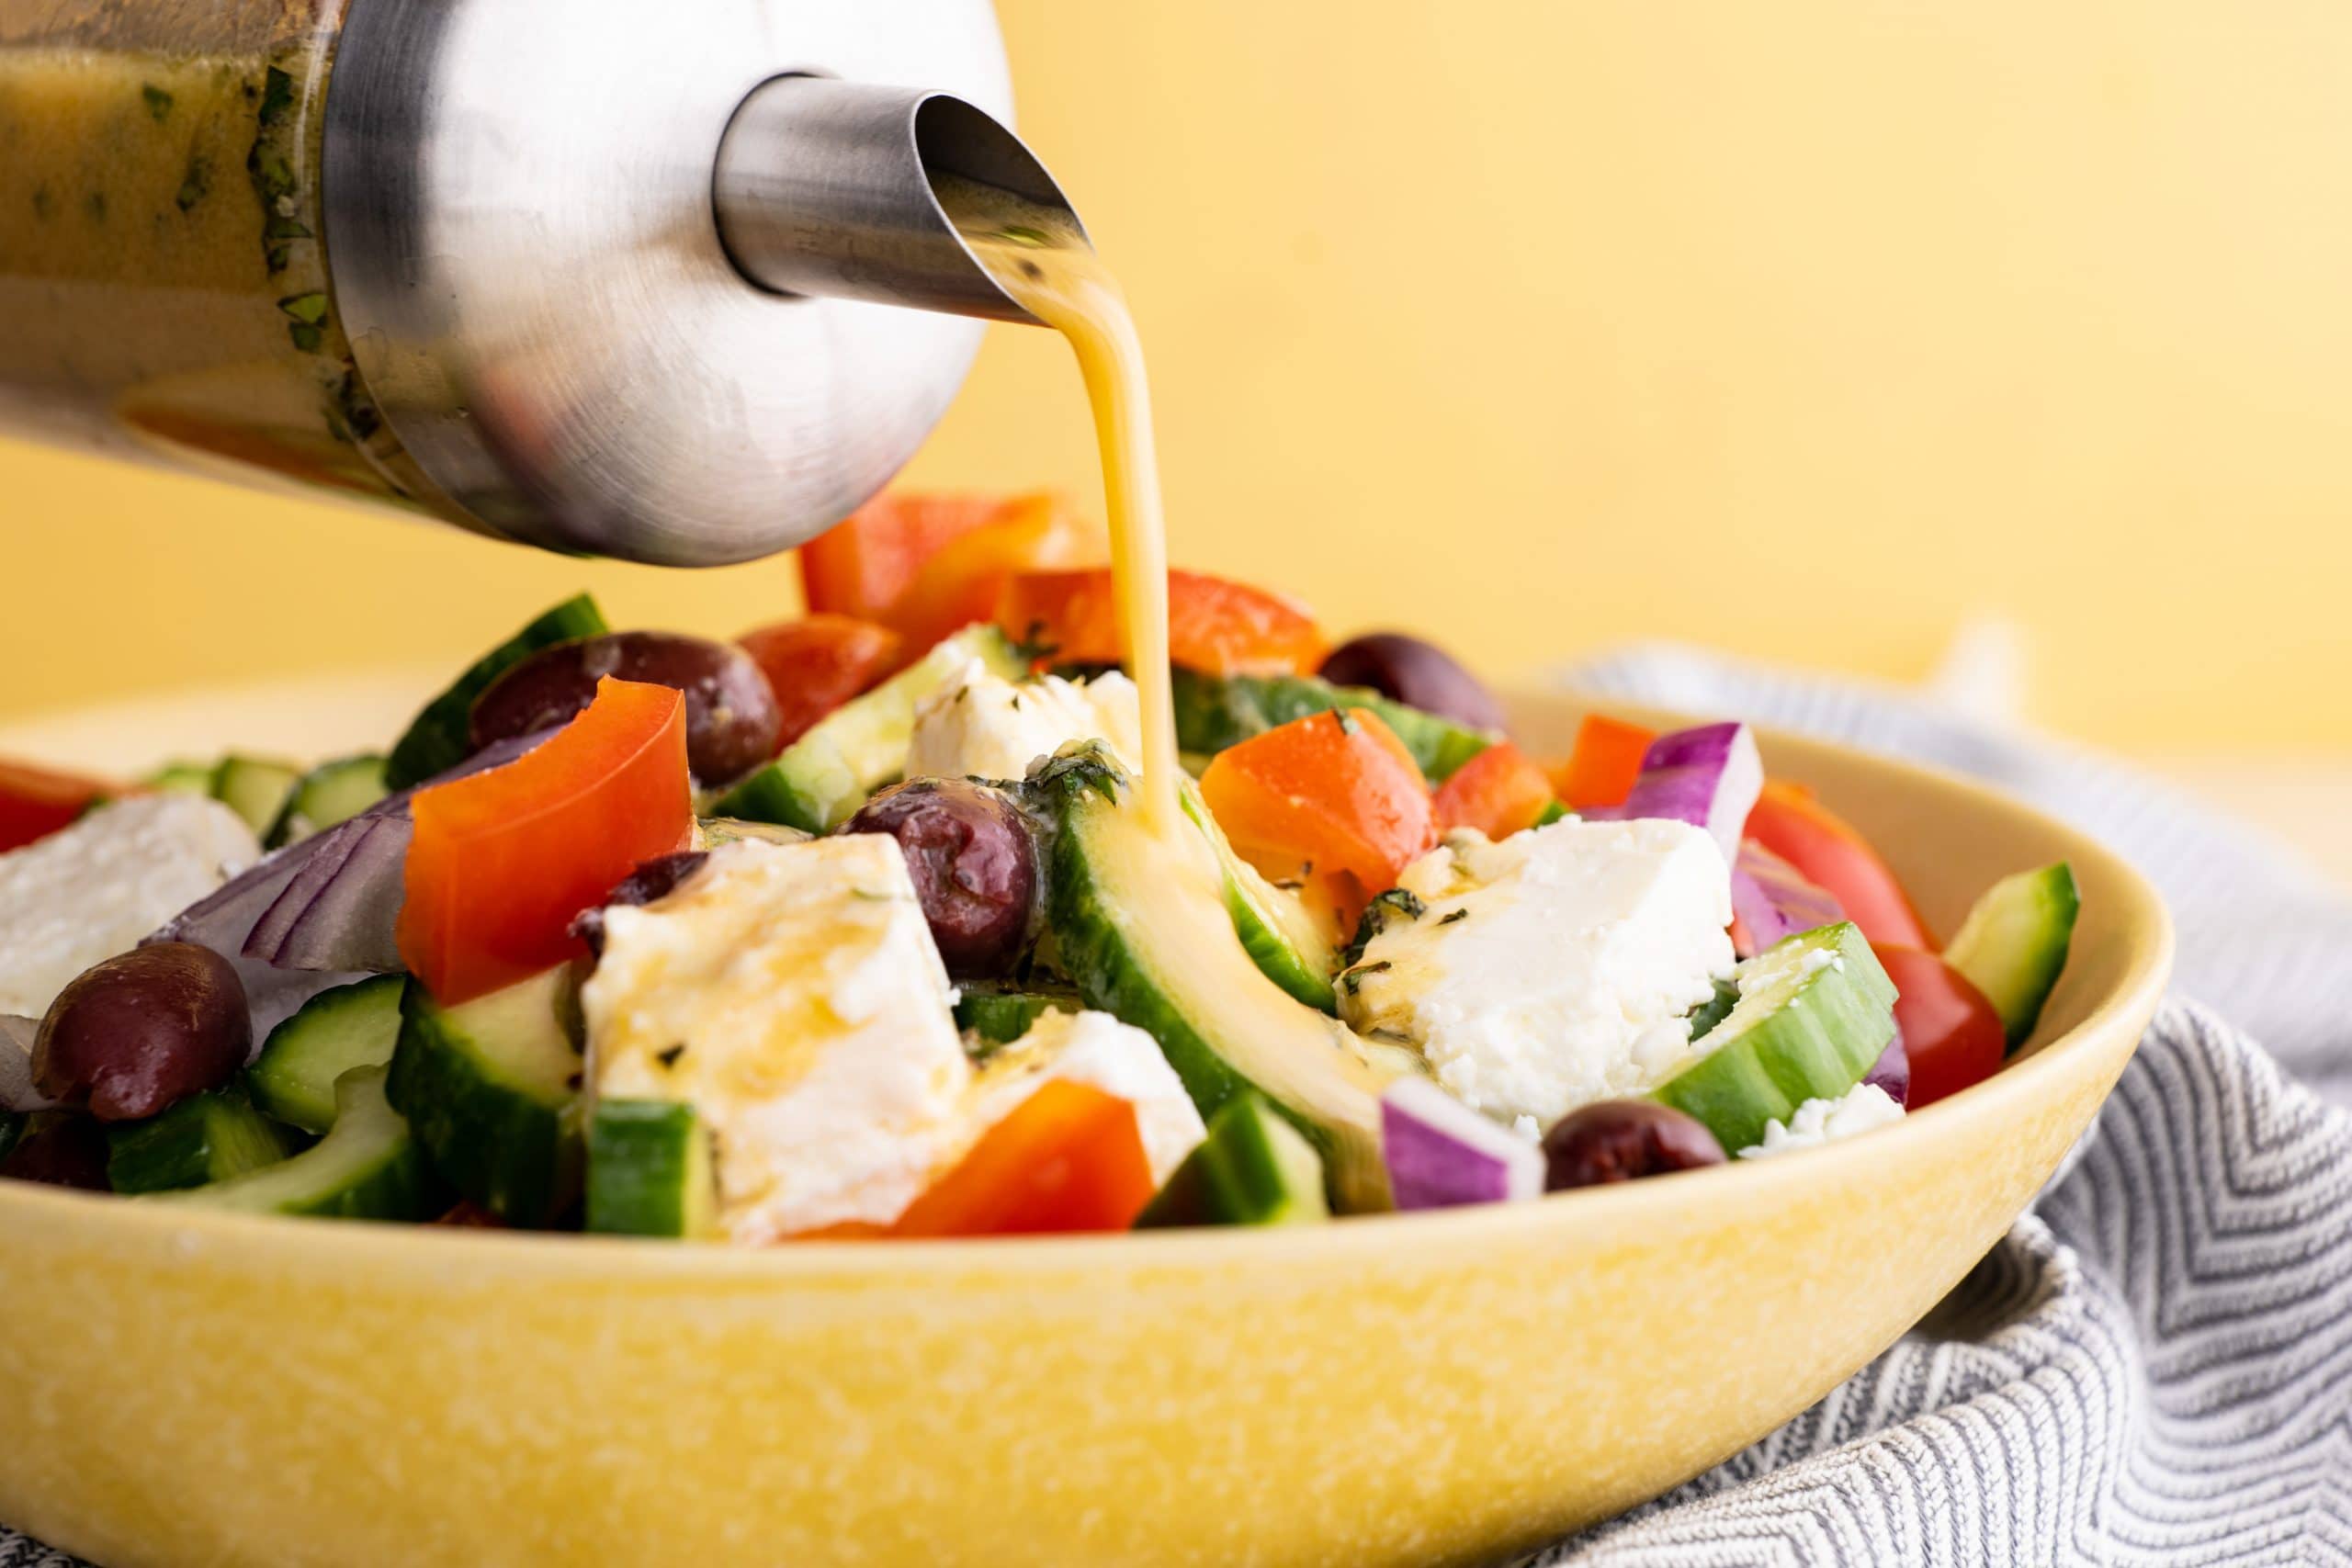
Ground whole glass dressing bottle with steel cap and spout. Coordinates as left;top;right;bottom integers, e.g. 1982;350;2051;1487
0;0;1081;564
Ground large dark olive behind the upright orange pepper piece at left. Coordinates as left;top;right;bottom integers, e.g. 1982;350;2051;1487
470;632;783;785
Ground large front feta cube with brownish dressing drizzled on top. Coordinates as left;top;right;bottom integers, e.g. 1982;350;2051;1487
581;835;971;1244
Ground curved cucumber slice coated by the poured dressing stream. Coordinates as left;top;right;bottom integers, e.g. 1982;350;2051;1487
1030;745;1390;1211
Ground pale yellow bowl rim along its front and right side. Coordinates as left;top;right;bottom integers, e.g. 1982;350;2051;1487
0;686;2176;1286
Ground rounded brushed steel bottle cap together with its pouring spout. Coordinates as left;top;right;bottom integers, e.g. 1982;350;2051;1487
324;0;1095;567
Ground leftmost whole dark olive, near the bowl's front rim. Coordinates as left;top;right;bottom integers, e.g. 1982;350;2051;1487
33;942;254;1122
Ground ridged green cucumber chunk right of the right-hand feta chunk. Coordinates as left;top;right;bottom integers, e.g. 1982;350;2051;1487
1649;921;1895;1149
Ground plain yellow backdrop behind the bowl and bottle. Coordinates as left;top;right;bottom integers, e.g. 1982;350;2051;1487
0;0;2352;750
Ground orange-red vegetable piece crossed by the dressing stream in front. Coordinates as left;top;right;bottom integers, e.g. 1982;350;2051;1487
997;567;1324;674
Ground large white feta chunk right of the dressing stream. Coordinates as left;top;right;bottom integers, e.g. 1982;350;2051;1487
1340;818;1731;1126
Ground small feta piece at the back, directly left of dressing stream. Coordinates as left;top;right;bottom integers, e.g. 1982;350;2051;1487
906;659;1143;778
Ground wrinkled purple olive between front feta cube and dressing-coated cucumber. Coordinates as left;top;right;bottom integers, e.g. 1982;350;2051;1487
842;778;1037;980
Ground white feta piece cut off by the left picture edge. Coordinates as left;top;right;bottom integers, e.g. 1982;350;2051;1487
0;795;261;1018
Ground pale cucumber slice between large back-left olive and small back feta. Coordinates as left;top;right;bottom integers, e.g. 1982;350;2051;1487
713;626;1028;832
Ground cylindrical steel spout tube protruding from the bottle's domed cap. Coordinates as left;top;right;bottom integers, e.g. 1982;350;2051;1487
713;75;1084;324
